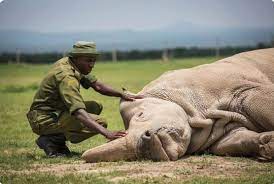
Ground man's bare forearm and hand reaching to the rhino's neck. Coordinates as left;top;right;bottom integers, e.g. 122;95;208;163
90;80;143;101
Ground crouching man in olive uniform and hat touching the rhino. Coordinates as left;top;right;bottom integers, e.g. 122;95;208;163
27;41;142;157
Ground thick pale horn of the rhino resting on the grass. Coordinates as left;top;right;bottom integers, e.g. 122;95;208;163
82;137;136;162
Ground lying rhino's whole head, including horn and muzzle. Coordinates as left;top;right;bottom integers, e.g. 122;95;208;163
82;98;191;162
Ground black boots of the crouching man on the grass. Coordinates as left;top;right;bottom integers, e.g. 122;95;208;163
36;134;70;157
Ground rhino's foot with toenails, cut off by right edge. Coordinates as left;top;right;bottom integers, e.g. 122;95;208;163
258;131;274;161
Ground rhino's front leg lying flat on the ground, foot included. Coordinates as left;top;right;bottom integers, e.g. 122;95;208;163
209;127;274;160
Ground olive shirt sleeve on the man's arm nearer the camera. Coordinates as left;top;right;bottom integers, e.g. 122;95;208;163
59;76;86;114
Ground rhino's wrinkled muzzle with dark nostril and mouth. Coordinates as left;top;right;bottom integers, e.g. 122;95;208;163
137;127;188;161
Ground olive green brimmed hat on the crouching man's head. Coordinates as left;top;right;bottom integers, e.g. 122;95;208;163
68;41;100;57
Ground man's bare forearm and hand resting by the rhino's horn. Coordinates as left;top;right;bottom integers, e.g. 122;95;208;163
73;109;127;140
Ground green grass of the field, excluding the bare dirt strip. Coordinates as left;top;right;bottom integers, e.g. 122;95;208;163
0;58;274;184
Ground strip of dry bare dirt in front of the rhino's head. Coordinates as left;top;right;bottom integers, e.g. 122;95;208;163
6;156;273;182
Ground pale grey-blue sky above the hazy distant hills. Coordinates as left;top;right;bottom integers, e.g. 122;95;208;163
0;0;274;32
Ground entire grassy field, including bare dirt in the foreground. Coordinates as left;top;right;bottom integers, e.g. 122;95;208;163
0;58;274;184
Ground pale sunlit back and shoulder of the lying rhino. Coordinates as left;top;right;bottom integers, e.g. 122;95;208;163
140;49;274;111
